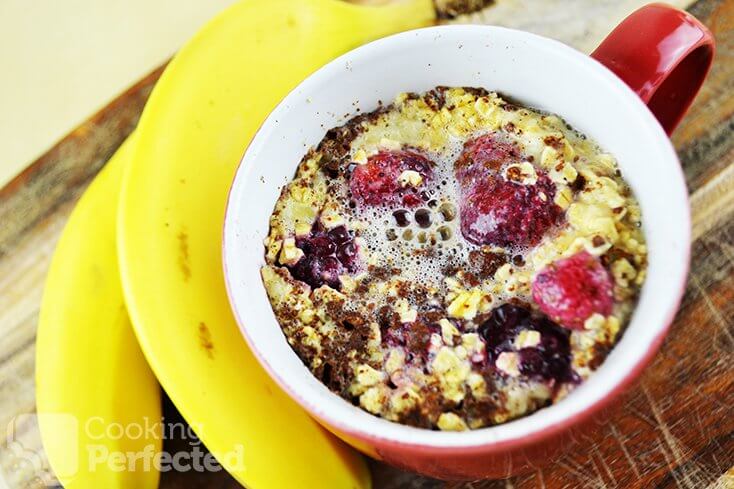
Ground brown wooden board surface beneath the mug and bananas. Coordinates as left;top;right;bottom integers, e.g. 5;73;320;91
0;0;734;489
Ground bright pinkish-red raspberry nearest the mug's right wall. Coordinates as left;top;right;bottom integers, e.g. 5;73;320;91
532;251;614;329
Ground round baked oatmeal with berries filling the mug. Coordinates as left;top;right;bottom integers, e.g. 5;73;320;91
262;87;647;430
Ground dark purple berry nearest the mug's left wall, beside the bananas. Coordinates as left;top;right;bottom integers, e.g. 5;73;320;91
288;221;359;290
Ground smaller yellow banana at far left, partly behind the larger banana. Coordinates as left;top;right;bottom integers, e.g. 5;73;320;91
36;137;161;489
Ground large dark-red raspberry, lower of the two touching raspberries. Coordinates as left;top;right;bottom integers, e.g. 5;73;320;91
459;170;563;246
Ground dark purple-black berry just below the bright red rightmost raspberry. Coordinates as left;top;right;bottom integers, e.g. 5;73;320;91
479;304;576;383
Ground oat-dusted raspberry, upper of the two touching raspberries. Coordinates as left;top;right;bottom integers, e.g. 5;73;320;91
454;133;521;186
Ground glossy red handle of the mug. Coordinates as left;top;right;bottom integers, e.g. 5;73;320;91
591;3;715;134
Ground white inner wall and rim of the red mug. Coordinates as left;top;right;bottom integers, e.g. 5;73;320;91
223;26;690;447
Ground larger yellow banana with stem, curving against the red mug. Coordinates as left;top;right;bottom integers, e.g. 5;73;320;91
119;0;435;488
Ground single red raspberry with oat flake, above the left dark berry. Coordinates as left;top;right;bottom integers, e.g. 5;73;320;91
349;151;433;207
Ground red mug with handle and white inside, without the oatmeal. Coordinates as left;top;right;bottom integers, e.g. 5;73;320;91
223;4;714;480
